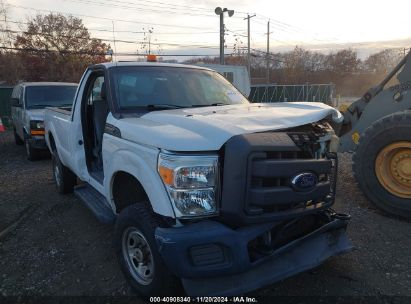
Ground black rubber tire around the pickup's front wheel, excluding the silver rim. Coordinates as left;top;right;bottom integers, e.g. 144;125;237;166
114;202;181;297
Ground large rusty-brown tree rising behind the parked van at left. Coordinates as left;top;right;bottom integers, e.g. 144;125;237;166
14;13;110;81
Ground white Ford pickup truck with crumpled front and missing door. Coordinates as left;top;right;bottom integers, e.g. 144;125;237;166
45;63;352;296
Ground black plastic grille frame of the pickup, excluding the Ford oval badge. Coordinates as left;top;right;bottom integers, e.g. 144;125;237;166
220;132;337;226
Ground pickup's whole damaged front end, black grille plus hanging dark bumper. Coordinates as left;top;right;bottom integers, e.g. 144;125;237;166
156;121;352;296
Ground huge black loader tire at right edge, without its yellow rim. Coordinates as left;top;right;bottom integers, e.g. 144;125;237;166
353;110;411;218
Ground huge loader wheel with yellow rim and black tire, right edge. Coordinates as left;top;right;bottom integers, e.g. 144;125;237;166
353;111;411;218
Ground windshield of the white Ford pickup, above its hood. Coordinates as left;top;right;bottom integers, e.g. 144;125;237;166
111;66;248;110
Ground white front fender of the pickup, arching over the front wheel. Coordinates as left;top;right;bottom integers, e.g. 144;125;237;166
103;134;175;217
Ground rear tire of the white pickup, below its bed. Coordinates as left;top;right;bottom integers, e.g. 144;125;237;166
51;151;77;194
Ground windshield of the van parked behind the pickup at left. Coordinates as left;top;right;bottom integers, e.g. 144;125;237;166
26;85;77;109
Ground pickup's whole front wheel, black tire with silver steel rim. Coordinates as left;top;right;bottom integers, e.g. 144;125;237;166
114;202;179;297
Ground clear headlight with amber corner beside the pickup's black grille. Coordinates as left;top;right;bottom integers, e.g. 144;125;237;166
158;153;218;218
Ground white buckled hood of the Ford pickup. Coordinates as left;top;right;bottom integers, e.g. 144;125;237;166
111;102;343;151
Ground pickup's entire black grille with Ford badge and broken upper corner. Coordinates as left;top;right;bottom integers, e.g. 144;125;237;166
220;121;338;226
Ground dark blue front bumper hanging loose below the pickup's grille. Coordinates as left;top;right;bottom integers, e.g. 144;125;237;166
156;214;352;296
